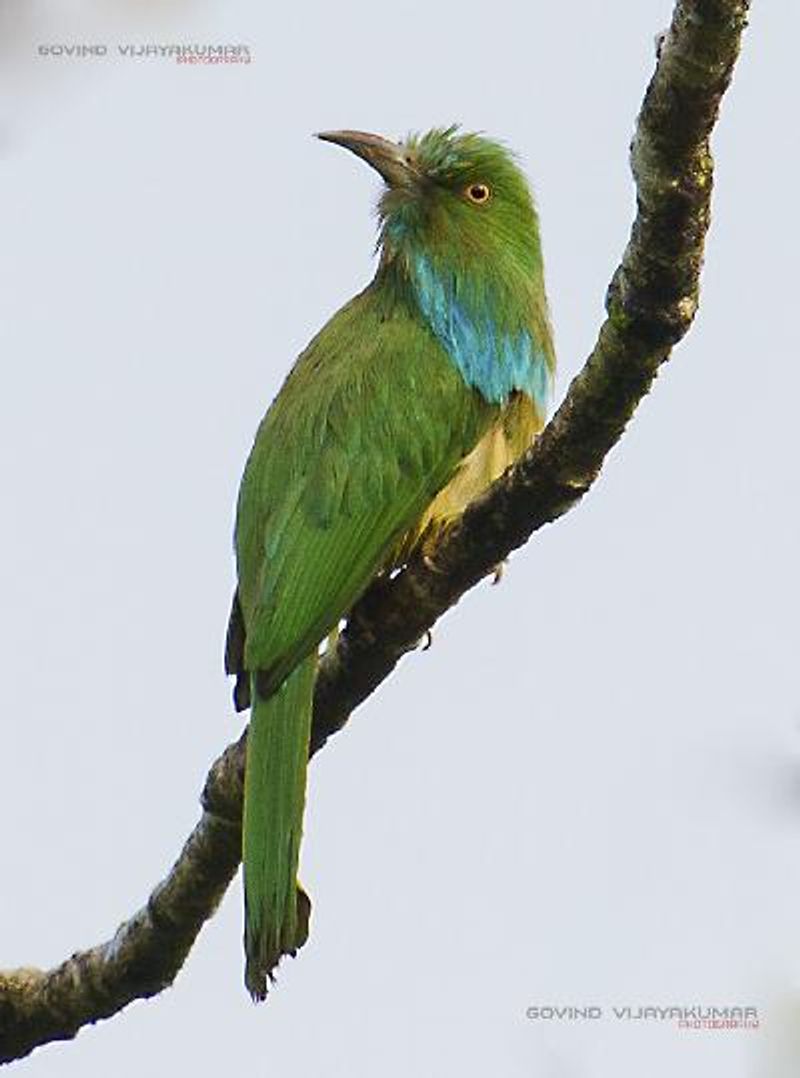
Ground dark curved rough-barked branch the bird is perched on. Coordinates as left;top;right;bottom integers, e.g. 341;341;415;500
0;0;749;1062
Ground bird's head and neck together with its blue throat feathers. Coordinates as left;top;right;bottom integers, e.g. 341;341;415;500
319;127;555;407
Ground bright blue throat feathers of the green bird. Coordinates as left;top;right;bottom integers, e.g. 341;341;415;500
410;253;551;415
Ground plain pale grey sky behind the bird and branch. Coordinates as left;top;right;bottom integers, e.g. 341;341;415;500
0;0;800;1078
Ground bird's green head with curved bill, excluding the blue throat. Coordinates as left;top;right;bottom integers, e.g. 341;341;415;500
319;126;541;276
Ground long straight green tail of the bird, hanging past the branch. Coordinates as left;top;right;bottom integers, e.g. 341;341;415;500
243;651;317;999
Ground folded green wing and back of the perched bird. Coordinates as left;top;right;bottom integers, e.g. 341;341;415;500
236;284;496;687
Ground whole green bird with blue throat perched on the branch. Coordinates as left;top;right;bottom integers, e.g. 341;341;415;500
225;126;555;999
